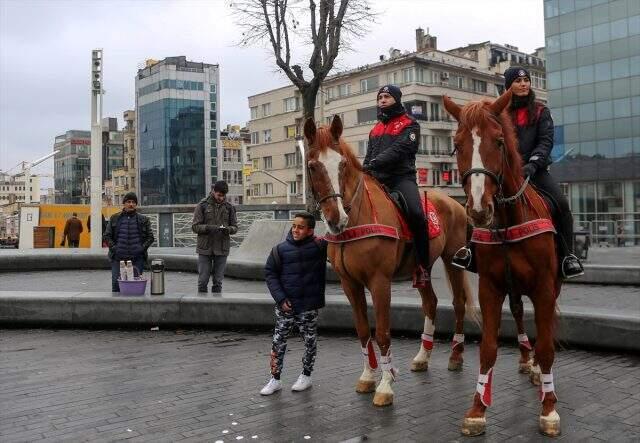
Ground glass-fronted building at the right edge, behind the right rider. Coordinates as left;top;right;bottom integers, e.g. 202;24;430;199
544;0;640;245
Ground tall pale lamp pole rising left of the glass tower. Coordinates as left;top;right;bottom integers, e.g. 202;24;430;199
90;49;103;251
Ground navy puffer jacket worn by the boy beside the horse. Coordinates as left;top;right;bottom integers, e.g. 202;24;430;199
264;231;327;314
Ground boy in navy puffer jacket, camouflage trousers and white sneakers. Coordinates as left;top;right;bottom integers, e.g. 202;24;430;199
260;212;327;395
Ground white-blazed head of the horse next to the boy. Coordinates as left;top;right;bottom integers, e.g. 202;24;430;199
304;115;349;234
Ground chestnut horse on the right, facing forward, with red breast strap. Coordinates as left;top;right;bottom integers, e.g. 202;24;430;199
444;91;561;436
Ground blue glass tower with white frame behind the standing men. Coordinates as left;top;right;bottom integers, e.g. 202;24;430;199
136;56;219;206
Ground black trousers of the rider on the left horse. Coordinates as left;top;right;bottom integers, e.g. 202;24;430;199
385;177;429;269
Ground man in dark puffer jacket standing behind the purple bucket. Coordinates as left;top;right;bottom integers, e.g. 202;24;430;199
103;192;154;292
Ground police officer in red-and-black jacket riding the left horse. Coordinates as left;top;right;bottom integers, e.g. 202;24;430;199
363;85;431;288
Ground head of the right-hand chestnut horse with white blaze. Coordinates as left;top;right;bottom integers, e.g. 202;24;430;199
443;91;511;227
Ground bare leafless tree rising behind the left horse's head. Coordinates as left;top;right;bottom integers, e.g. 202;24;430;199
231;0;376;121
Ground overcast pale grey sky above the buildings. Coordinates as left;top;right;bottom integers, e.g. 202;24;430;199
0;0;544;182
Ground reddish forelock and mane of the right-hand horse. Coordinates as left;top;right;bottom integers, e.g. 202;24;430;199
460;100;522;187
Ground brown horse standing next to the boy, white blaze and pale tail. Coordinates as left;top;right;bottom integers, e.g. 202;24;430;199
304;116;476;406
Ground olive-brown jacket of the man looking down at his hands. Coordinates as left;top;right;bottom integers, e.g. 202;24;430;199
191;195;238;255
